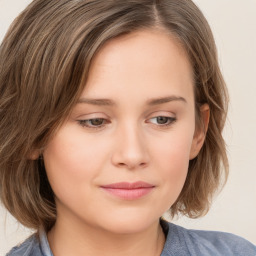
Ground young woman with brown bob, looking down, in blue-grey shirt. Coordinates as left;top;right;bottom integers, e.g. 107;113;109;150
0;0;256;256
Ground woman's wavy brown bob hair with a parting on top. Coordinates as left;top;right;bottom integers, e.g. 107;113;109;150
0;0;228;231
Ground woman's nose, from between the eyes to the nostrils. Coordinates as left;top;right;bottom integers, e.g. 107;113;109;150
112;124;149;170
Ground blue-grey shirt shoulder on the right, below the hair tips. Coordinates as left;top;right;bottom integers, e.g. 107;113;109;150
163;220;256;256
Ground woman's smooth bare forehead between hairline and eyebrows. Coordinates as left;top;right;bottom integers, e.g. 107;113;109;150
83;30;193;103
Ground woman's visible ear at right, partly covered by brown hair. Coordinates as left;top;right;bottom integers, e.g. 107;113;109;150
189;104;210;160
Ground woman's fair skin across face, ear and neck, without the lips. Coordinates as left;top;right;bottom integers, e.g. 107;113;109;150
43;30;209;256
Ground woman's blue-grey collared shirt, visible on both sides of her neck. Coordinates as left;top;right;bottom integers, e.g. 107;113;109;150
6;220;256;256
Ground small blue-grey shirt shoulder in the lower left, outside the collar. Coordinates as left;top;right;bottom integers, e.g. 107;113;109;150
6;235;43;256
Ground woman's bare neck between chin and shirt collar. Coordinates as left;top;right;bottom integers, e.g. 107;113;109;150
48;216;165;256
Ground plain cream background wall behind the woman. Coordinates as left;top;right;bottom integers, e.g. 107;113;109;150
0;0;256;256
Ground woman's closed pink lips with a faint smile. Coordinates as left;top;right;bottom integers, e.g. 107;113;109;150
101;181;155;200
